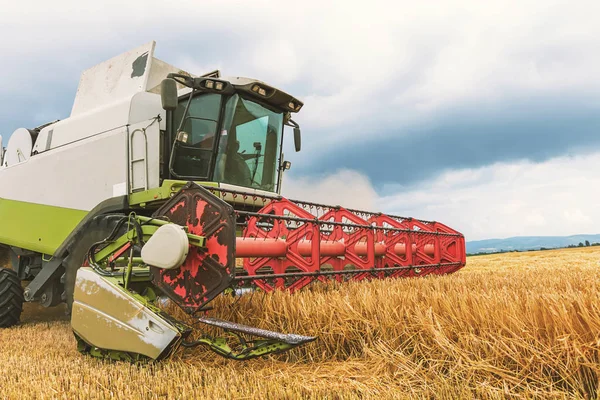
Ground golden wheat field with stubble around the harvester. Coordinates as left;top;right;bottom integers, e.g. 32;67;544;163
0;247;600;399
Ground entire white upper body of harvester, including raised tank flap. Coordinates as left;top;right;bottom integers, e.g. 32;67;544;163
0;42;170;211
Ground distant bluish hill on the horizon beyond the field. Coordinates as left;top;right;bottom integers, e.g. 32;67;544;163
467;234;600;254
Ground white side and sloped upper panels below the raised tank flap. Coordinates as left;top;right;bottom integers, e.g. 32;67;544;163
0;93;164;211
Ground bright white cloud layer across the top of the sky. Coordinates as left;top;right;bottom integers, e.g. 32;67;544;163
0;0;600;133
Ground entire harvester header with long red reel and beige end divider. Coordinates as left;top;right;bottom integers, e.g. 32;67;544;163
72;182;465;360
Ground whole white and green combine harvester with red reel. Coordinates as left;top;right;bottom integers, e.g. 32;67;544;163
0;42;465;360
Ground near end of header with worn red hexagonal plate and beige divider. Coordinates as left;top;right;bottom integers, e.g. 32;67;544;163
71;183;315;361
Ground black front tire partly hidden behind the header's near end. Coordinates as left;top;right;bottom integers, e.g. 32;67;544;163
63;214;123;314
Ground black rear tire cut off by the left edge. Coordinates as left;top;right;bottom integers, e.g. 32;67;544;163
0;268;25;328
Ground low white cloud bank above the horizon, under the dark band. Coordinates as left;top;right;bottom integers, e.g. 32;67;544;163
284;152;600;240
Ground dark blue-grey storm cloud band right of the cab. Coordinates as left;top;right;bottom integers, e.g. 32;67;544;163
295;96;600;188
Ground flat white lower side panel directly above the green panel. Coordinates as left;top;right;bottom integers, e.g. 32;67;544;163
0;113;160;211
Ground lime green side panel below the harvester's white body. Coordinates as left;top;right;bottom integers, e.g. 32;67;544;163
0;198;87;254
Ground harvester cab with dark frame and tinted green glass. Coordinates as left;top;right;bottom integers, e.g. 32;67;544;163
161;72;302;197
